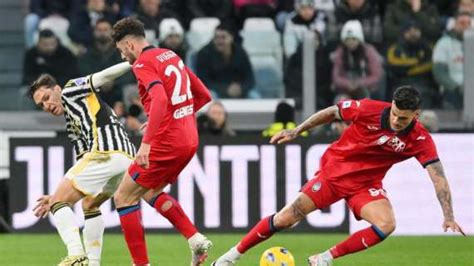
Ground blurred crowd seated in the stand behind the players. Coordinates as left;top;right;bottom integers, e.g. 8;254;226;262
23;0;466;136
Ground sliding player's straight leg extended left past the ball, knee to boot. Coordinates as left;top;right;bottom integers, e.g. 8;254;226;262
211;193;316;266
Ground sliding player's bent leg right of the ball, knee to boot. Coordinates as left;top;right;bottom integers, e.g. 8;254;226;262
308;199;395;266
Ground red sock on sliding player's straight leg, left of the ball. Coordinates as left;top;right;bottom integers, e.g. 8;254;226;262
237;215;279;254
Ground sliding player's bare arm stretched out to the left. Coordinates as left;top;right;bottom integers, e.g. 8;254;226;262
270;105;341;144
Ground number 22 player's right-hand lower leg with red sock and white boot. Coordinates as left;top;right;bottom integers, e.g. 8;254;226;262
148;192;212;266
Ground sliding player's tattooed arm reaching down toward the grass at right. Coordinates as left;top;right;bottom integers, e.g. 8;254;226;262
426;162;465;235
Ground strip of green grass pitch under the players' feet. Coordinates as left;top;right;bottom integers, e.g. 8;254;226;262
0;233;474;266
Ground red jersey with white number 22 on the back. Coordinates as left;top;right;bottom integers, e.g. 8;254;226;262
132;46;211;150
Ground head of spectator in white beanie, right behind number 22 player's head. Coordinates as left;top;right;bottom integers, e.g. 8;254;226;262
160;18;188;60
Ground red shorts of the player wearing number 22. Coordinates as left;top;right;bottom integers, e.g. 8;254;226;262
128;147;197;189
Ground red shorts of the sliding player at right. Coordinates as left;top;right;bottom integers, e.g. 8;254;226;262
301;175;388;220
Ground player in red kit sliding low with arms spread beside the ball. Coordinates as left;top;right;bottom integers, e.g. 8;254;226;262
212;86;464;266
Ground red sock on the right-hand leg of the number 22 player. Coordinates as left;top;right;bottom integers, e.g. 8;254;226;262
151;192;198;239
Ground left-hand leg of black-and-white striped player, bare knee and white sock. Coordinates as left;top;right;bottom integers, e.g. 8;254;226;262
50;178;88;266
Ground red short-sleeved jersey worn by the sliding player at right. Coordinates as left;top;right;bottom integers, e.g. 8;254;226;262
320;99;438;191
